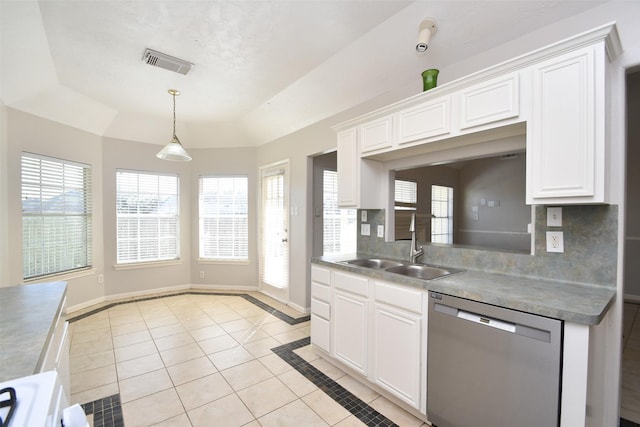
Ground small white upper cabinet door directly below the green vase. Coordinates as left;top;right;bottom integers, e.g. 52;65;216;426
398;97;451;144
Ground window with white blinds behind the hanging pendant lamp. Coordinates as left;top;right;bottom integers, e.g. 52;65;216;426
116;170;180;264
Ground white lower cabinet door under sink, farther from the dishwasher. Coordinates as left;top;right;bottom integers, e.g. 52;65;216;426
331;290;369;375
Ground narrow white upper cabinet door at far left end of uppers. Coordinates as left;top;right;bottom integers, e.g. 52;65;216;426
337;128;360;207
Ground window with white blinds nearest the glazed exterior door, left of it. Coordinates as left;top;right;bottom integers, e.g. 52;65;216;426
199;176;249;261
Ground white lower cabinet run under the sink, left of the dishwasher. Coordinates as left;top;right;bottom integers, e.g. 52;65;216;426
311;265;427;414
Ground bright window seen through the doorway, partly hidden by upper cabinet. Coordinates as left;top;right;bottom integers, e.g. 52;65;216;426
322;169;358;255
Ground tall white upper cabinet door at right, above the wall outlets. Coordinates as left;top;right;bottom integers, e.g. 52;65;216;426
527;47;605;204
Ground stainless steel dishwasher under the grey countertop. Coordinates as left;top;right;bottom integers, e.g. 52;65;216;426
427;292;563;427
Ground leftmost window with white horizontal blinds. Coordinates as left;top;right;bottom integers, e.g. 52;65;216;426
21;153;92;279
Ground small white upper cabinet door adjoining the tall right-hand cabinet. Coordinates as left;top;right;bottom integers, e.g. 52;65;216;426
460;73;520;129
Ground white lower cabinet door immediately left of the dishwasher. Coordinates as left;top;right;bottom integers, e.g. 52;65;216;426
373;304;421;409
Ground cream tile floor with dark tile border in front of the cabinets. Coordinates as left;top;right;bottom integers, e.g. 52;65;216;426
70;292;428;427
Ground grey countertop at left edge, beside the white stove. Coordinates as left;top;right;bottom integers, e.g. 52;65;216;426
0;282;67;382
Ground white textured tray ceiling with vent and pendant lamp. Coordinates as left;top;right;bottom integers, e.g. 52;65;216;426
0;0;604;148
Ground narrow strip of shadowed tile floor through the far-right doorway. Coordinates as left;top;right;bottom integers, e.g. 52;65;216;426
620;303;640;427
